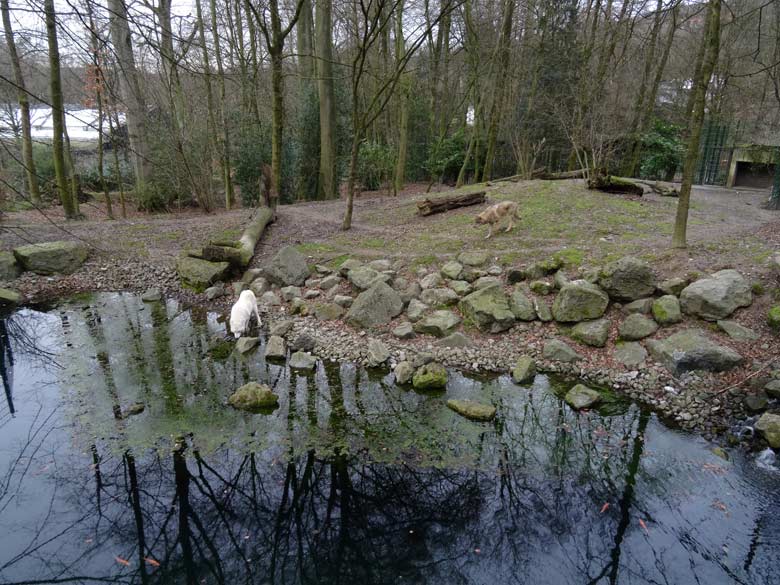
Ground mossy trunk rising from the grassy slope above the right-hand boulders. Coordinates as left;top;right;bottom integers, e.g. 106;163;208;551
672;0;721;248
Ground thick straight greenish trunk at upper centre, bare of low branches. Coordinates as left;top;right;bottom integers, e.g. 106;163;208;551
315;0;338;199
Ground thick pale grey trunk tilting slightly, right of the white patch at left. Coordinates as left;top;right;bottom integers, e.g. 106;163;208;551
108;0;151;193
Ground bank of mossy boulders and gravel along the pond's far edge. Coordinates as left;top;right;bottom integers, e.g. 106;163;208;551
218;247;780;446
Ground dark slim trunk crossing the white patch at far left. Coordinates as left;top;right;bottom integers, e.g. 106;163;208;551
43;0;78;219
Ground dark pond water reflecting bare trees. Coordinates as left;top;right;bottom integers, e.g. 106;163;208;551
0;294;780;585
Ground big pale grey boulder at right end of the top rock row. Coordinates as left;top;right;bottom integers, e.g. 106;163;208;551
680;270;753;321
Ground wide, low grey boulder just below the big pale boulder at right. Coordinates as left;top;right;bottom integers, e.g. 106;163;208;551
647;329;743;375
